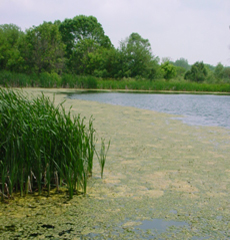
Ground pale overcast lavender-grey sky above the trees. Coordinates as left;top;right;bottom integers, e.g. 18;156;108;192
0;0;230;66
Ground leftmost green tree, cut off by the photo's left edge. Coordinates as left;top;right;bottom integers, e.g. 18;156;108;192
0;24;24;71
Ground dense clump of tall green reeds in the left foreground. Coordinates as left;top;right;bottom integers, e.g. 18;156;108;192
0;88;100;199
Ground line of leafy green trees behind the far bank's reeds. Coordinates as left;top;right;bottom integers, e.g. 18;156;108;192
0;15;230;83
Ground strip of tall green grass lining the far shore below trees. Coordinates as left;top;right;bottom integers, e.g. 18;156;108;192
0;71;230;93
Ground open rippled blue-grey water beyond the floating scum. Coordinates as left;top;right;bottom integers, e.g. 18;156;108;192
69;93;230;128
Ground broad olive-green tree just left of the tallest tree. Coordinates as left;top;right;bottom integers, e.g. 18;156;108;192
19;22;65;73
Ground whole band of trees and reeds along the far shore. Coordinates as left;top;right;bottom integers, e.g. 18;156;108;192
0;15;230;92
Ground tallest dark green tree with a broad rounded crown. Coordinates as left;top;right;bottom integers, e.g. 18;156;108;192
59;15;112;73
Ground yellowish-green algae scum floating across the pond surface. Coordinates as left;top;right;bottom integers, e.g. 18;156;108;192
0;89;230;239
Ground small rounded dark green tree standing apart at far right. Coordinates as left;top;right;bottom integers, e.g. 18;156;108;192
184;62;208;82
